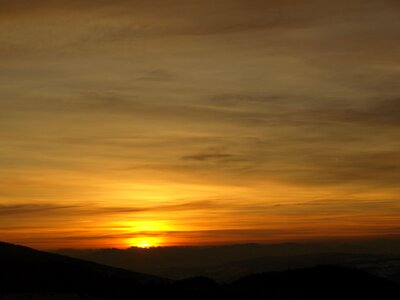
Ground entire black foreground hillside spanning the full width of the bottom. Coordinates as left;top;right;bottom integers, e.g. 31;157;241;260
0;243;400;300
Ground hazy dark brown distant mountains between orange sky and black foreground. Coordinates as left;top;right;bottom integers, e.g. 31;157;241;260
59;242;400;283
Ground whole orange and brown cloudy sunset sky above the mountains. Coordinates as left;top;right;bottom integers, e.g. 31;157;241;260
0;0;400;249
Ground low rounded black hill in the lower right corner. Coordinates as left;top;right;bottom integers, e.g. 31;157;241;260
224;266;400;300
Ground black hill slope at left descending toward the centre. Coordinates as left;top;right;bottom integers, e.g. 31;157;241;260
0;242;169;299
